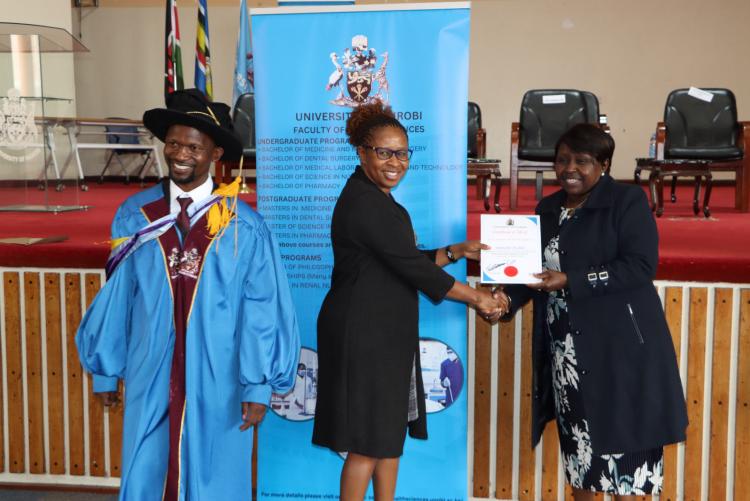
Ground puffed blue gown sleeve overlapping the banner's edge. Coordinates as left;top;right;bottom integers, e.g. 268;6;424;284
239;224;300;405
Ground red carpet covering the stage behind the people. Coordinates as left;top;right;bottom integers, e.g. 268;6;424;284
0;183;750;283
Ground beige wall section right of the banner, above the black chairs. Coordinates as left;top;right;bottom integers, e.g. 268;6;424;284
469;0;750;179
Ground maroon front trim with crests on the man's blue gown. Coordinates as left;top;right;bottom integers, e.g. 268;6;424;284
141;198;213;501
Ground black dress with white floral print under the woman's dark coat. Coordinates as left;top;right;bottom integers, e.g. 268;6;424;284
544;210;663;496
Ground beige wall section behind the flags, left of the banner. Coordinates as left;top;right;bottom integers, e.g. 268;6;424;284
71;0;276;119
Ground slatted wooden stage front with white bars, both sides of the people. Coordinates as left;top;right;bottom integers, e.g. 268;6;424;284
0;268;750;501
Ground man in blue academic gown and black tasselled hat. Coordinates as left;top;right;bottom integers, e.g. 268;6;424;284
76;89;299;501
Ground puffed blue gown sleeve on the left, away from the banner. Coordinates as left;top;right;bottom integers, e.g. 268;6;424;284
76;260;134;393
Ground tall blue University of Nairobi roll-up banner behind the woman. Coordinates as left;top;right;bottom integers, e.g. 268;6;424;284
251;2;469;500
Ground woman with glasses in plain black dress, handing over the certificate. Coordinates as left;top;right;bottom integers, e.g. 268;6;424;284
313;102;507;501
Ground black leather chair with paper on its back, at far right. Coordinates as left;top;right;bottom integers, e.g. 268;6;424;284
635;88;750;214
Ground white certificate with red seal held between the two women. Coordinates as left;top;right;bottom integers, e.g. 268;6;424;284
480;214;542;284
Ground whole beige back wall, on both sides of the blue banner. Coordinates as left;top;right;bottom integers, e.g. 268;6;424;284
70;0;750;179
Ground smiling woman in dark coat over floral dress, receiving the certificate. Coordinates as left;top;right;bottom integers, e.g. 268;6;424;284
505;124;687;501
